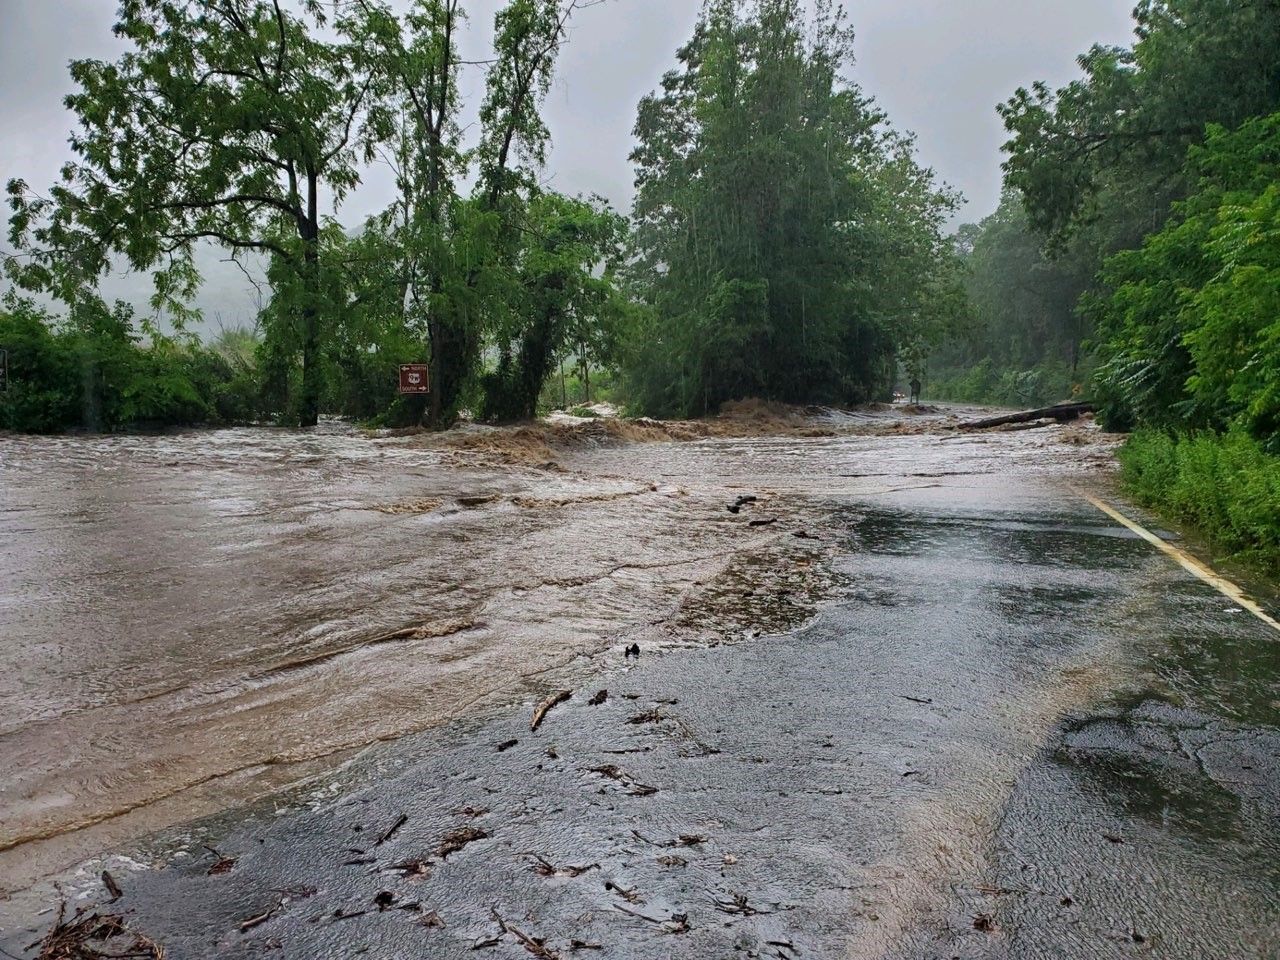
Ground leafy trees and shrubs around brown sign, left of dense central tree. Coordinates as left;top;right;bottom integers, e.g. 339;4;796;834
0;0;626;429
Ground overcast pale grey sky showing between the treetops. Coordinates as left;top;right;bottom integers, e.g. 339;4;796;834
0;0;1133;323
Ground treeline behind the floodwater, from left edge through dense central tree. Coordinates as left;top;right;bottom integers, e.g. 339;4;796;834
0;0;960;430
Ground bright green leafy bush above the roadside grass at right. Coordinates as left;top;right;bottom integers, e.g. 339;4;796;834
1088;114;1280;442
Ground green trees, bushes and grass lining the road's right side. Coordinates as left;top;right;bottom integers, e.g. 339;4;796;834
936;0;1280;568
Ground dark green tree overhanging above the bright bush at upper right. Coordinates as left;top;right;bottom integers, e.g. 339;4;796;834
1000;0;1280;253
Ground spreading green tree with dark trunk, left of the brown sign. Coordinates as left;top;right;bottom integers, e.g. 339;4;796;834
9;0;390;425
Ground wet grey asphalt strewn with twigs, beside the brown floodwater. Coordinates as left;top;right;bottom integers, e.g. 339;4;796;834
0;422;1280;960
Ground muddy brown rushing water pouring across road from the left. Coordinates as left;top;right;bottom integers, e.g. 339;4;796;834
0;416;1108;888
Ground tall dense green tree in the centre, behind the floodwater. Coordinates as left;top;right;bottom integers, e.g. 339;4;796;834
623;0;952;413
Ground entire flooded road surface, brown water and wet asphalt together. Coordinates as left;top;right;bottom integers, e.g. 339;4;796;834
0;410;1280;960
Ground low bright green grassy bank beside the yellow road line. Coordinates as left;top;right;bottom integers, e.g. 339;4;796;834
1120;430;1280;577
